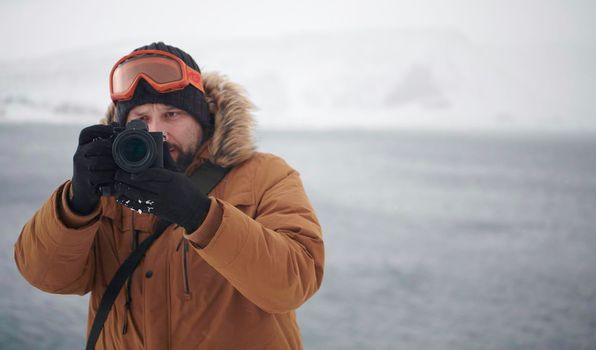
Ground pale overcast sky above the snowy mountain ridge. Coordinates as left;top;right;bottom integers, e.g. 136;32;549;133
0;0;596;59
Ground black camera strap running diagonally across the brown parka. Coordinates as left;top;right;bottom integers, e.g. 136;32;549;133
85;160;232;350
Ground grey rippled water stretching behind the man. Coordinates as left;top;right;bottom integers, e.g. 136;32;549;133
0;125;596;349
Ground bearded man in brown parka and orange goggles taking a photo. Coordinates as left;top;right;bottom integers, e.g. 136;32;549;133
15;42;324;350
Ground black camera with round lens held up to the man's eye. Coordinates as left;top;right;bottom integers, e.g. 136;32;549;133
100;119;163;196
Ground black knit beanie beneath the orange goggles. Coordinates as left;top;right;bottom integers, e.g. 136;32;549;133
116;41;215;140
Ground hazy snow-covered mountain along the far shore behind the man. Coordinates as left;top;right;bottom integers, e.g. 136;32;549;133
0;28;596;130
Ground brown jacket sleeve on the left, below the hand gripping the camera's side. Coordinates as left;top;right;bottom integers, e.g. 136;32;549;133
14;180;101;295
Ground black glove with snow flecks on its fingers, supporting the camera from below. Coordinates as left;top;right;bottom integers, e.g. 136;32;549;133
114;142;211;233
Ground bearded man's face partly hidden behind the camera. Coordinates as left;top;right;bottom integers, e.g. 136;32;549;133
126;103;203;170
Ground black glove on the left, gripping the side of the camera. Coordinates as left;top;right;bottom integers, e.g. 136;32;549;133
69;124;117;215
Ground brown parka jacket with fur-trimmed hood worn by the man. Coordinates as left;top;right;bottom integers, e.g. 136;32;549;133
15;73;324;350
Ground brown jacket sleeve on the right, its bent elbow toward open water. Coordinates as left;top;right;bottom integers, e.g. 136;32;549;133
186;156;324;313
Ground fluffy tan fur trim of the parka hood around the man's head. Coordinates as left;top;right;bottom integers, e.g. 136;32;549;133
101;72;256;170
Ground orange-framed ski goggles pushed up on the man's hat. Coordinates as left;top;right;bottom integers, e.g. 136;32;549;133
110;50;205;102
